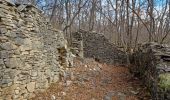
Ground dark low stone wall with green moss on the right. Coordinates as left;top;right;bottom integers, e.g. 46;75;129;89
131;43;170;100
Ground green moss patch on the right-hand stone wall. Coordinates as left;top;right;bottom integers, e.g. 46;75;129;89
159;73;170;90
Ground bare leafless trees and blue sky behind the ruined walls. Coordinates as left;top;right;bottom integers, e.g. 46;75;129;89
13;0;170;51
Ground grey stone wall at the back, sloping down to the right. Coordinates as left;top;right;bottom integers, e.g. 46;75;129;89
72;30;127;64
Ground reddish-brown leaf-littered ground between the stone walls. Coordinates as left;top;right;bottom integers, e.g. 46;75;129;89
33;59;149;100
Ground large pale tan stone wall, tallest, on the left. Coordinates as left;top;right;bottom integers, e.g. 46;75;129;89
0;0;72;100
